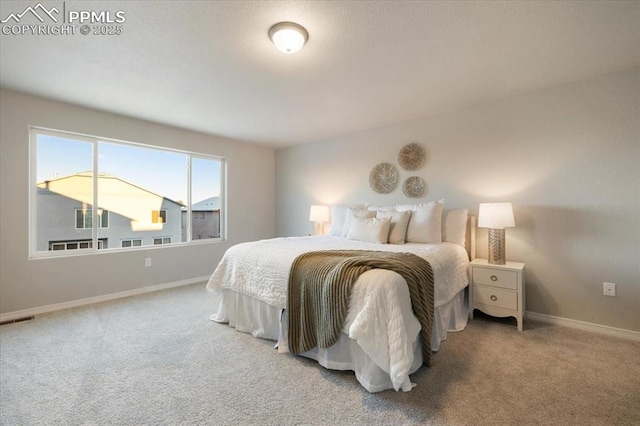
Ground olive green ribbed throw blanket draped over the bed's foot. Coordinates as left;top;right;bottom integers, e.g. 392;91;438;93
287;250;434;365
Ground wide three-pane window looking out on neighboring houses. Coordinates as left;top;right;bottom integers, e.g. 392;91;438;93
30;127;225;257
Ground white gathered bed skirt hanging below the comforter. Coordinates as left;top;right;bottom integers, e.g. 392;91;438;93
210;289;468;392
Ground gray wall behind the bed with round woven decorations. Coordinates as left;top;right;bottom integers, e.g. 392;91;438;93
276;67;640;331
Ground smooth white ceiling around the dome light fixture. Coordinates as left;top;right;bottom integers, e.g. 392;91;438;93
0;0;640;148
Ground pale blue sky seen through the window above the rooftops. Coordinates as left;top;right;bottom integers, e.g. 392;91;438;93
36;134;221;204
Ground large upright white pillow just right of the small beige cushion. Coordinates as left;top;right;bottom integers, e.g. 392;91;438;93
398;200;444;243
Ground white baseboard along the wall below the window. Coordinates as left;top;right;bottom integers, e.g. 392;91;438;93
0;276;209;323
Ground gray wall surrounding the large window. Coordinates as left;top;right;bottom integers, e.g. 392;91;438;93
0;90;275;313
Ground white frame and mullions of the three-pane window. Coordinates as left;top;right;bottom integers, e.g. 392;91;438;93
28;126;228;259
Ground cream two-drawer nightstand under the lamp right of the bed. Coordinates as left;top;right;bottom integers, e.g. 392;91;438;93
469;259;525;331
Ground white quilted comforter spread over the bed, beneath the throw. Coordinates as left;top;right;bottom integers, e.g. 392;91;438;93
207;236;468;391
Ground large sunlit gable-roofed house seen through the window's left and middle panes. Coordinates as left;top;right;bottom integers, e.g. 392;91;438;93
36;172;184;251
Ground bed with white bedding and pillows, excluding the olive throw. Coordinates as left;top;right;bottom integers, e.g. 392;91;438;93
207;201;475;392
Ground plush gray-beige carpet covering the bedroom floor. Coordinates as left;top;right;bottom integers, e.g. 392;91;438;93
0;285;640;425
